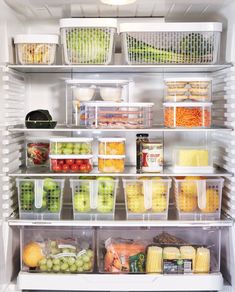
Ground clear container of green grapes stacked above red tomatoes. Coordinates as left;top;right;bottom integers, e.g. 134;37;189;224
50;137;93;155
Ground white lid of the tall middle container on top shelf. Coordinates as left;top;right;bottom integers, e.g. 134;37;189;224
60;18;117;28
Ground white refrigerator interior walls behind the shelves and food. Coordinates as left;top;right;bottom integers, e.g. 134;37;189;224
0;0;235;291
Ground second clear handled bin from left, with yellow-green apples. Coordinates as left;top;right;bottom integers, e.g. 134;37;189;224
70;176;118;220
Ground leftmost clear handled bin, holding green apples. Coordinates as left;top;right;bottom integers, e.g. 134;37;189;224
16;178;64;220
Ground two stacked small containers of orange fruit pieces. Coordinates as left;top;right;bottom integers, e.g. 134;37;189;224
98;138;126;173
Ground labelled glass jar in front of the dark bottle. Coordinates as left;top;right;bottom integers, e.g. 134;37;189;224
142;142;163;172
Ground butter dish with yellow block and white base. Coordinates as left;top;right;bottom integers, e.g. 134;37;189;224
173;147;213;173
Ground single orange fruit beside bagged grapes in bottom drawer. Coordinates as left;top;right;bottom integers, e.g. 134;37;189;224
22;241;44;268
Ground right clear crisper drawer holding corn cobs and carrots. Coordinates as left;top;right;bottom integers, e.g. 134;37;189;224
97;227;221;274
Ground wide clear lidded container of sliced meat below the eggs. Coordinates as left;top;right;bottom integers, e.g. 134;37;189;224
75;102;154;129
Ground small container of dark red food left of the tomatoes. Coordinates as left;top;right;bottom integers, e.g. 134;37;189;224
26;139;50;167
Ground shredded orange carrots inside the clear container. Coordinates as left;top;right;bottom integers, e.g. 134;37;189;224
164;107;211;128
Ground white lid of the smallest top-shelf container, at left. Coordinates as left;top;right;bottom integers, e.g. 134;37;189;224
14;34;59;44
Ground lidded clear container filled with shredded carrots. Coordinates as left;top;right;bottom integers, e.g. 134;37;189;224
163;102;212;128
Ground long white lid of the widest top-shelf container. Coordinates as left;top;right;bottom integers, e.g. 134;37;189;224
119;22;222;33
